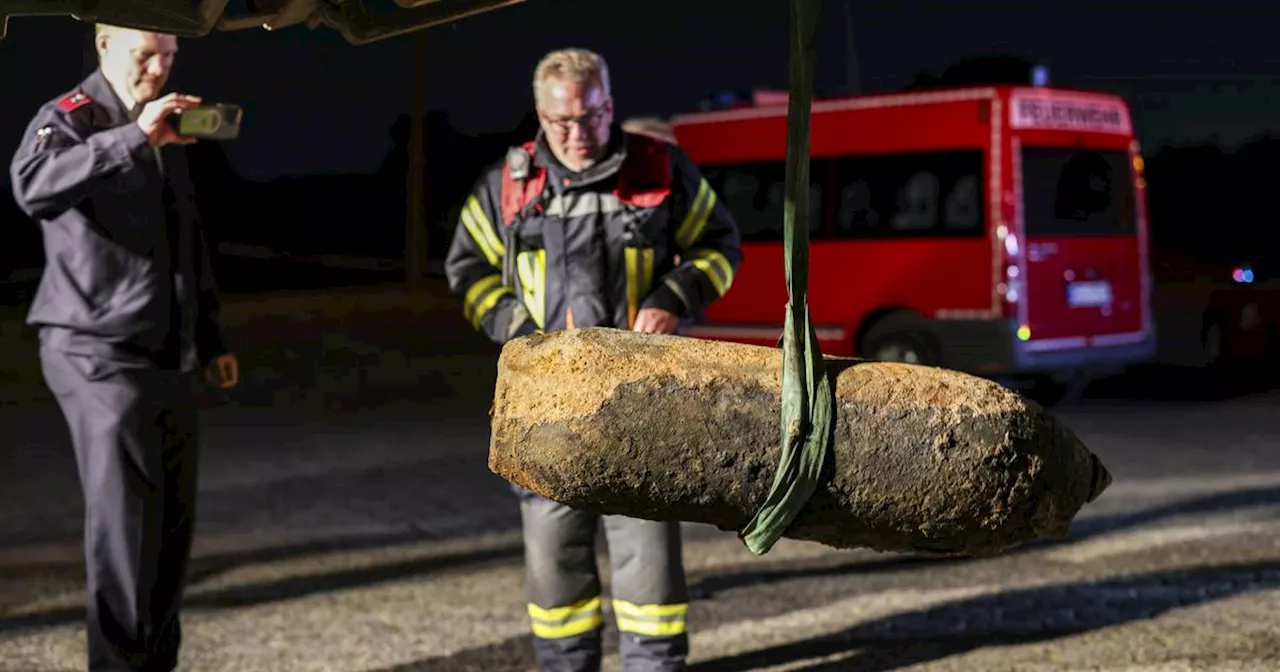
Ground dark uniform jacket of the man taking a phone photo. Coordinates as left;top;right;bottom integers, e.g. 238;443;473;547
10;70;225;369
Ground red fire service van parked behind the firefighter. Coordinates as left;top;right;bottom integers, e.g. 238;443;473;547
672;84;1155;399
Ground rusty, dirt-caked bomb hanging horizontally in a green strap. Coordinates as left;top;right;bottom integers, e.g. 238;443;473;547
489;329;1110;556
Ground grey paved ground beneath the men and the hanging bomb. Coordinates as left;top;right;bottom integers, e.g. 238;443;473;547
0;355;1280;672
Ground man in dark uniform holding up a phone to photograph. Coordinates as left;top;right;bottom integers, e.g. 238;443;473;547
10;26;239;672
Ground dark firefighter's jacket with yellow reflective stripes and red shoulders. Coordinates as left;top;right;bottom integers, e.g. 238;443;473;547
445;128;742;343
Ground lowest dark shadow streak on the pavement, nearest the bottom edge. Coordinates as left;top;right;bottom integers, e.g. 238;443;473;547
376;563;1280;672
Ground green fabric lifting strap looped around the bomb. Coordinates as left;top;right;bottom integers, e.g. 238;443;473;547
740;0;835;556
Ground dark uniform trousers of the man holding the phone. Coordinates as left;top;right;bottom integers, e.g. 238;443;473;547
40;347;197;672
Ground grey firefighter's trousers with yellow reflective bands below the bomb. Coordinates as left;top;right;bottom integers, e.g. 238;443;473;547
517;490;689;672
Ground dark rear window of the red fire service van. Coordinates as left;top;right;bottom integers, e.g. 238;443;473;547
1021;147;1138;236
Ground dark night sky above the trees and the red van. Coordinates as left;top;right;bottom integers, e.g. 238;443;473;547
0;0;1280;182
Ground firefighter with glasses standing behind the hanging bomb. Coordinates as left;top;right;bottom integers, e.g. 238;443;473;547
445;49;741;671
